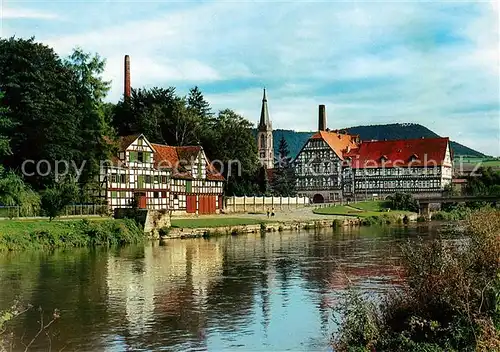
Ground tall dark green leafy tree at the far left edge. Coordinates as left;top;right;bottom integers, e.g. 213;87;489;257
0;37;110;189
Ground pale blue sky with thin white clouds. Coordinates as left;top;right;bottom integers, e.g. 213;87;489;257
0;0;500;156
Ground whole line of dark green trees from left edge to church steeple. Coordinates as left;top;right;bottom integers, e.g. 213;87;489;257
0;37;291;217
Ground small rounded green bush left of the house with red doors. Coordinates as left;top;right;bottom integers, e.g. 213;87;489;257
41;178;79;221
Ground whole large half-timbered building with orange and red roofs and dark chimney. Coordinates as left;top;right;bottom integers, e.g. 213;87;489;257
294;105;453;203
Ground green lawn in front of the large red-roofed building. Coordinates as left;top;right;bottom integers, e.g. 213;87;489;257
313;201;410;218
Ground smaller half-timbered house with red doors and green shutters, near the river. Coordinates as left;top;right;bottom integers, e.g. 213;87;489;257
99;134;224;214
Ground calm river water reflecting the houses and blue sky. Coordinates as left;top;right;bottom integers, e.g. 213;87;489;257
0;224;444;351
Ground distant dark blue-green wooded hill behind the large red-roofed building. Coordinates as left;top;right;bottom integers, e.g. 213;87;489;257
254;123;485;157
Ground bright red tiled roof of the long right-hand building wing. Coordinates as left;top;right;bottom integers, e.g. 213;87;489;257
344;138;449;169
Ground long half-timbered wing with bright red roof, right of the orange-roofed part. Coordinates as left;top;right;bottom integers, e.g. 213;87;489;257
343;138;452;198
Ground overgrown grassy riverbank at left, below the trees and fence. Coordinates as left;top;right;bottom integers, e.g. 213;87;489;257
0;219;144;251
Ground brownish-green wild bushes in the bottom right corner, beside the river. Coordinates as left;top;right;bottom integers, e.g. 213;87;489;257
332;209;500;352
